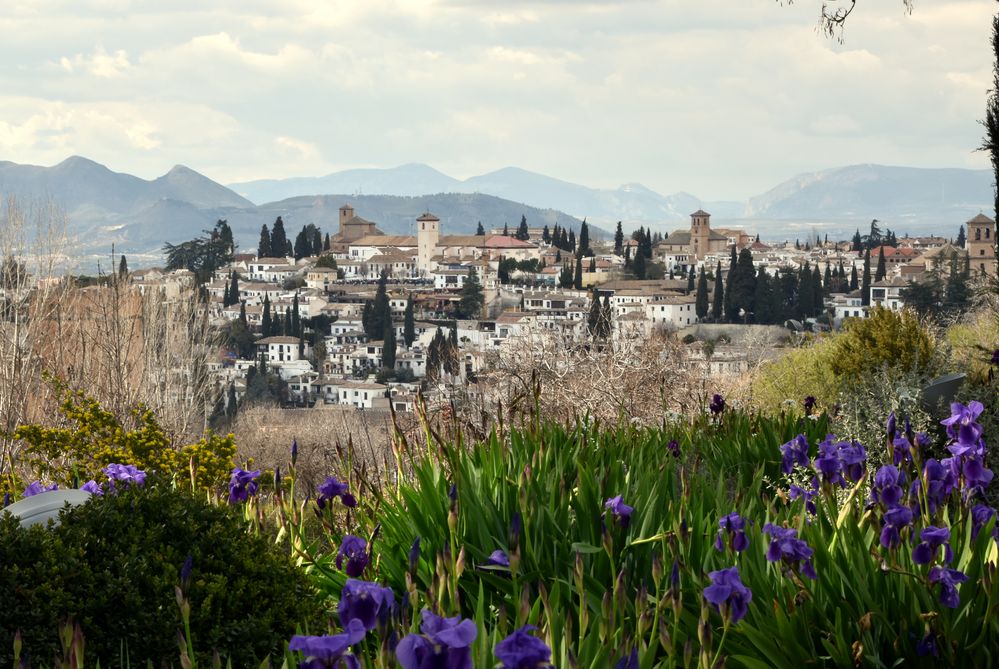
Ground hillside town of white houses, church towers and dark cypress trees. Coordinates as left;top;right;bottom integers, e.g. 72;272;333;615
129;204;997;412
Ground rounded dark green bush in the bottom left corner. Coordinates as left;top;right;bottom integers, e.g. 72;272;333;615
0;485;321;667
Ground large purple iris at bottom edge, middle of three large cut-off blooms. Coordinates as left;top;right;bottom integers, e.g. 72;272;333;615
395;609;478;669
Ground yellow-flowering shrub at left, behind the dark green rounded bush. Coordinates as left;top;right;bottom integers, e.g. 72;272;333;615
14;383;236;488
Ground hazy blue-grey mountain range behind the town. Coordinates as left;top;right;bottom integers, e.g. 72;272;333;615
0;156;993;262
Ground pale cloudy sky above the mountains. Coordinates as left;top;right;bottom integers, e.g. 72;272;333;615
0;0;997;200
